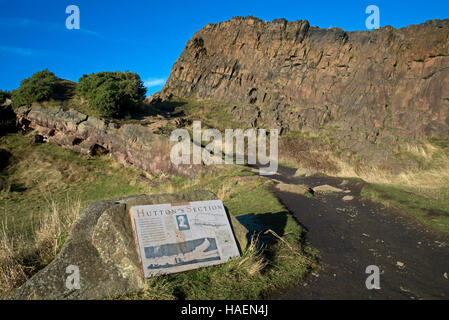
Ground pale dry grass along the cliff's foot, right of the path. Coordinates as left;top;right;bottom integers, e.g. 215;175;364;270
279;133;449;190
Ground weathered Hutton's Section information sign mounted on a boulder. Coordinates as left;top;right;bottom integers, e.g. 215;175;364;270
130;200;240;278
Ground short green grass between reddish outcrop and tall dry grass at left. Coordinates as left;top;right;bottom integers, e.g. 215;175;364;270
0;133;148;233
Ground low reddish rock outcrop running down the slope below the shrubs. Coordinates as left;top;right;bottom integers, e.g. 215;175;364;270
16;104;203;176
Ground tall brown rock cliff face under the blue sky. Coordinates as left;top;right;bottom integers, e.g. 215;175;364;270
161;17;449;150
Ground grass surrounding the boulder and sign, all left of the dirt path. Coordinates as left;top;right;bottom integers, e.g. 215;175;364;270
0;134;317;299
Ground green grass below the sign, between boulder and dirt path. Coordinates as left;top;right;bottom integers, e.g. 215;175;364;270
122;235;313;300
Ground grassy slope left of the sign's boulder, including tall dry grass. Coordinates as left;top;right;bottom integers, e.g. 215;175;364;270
0;133;148;298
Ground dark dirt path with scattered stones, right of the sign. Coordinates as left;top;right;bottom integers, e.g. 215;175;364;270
269;168;449;299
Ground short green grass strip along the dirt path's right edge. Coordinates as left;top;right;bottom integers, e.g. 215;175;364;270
361;184;449;233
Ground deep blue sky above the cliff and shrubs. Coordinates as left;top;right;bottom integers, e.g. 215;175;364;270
0;0;449;93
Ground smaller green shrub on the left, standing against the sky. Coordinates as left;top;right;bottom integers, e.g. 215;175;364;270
11;69;58;108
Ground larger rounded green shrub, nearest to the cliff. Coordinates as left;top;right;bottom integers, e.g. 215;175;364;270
76;71;146;117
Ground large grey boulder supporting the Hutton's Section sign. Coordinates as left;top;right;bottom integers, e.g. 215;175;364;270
11;190;248;299
